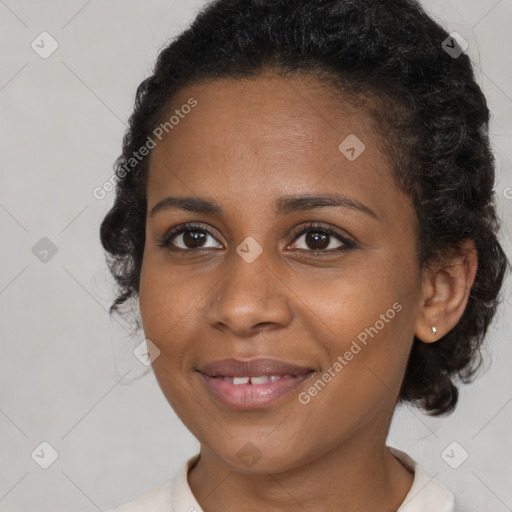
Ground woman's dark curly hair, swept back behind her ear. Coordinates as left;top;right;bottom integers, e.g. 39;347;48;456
100;0;508;415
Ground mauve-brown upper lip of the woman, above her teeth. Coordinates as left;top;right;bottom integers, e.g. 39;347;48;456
199;358;313;377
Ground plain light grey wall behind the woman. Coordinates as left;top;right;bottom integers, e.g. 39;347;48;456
0;0;512;512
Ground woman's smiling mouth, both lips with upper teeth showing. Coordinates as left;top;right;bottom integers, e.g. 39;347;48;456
199;359;315;410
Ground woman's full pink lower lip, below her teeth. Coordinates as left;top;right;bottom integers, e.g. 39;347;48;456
200;372;313;409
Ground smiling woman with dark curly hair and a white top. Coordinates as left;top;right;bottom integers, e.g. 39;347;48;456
101;0;507;512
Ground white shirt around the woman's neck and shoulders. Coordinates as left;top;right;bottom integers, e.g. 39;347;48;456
107;446;455;512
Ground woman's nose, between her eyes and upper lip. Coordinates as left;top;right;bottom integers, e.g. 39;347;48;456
208;251;292;337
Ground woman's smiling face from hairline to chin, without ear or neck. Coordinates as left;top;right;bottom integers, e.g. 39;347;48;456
139;76;421;472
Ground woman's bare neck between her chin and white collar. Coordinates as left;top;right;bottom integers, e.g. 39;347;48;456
188;440;414;512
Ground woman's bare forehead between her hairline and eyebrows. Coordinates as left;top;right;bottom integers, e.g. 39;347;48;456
148;75;391;215
